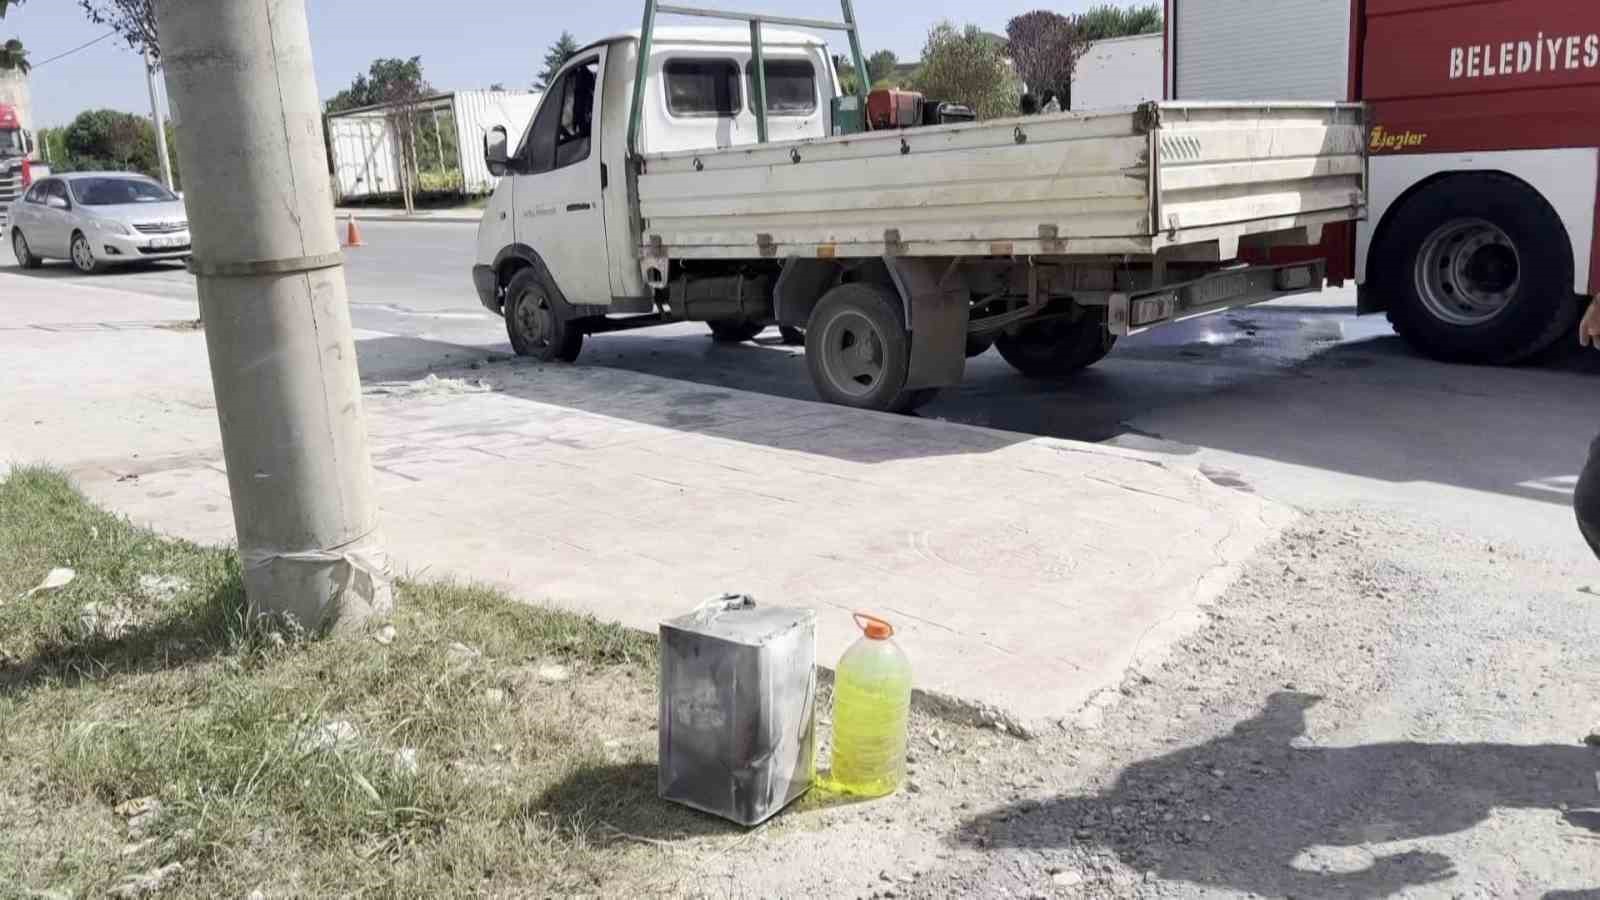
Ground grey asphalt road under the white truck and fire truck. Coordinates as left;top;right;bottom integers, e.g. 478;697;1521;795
0;216;1600;554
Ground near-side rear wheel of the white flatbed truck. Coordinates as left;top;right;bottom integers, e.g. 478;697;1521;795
805;283;938;413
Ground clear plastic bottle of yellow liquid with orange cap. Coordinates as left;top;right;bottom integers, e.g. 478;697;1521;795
832;613;910;798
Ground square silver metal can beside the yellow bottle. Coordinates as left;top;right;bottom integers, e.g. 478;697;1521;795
658;596;816;825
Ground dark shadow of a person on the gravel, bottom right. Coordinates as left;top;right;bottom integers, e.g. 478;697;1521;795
957;693;1600;897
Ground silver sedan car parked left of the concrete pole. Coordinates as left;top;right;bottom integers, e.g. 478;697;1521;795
10;171;189;272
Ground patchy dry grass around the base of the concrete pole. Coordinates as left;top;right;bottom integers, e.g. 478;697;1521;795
0;468;728;897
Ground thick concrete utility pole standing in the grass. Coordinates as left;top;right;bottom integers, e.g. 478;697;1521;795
155;0;392;629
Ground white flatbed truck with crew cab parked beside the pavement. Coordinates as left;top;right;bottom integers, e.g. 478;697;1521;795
474;0;1366;412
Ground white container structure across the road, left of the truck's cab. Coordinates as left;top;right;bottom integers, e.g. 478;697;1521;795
326;91;539;202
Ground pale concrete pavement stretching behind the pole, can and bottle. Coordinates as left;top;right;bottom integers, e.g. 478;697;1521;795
0;269;1293;727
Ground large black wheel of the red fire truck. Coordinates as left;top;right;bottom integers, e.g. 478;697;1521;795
1373;175;1584;365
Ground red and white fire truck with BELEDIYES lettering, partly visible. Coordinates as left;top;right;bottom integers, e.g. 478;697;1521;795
1165;0;1600;364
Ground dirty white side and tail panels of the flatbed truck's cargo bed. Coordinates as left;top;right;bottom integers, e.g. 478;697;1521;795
637;102;1366;259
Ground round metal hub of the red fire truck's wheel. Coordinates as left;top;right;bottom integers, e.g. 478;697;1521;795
1416;219;1522;327
